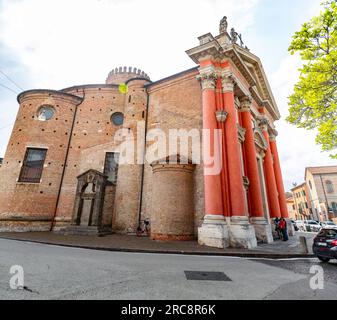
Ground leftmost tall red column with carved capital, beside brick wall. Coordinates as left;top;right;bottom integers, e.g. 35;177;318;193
201;74;224;216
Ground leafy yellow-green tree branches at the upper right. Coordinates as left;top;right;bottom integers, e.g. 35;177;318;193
287;0;337;159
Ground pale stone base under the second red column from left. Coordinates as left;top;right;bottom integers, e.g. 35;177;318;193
229;216;257;249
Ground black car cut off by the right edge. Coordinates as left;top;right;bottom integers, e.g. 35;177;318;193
312;228;337;262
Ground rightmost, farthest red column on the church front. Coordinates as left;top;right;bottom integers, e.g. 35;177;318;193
270;135;289;218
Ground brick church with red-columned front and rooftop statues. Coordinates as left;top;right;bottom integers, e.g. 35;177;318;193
0;17;288;248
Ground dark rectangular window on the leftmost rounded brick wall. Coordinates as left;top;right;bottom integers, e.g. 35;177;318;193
19;148;47;183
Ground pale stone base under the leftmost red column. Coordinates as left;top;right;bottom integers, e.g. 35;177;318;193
198;215;229;249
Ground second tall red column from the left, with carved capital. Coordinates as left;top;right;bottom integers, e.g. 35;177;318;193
222;78;246;217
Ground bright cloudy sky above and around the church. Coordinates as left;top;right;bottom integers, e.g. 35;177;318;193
0;0;335;189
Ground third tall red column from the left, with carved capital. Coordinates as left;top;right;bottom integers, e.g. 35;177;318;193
240;97;264;217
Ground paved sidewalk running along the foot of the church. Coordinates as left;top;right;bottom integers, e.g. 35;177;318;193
0;232;312;259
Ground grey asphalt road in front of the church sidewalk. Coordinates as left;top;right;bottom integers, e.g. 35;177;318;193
0;239;337;300
